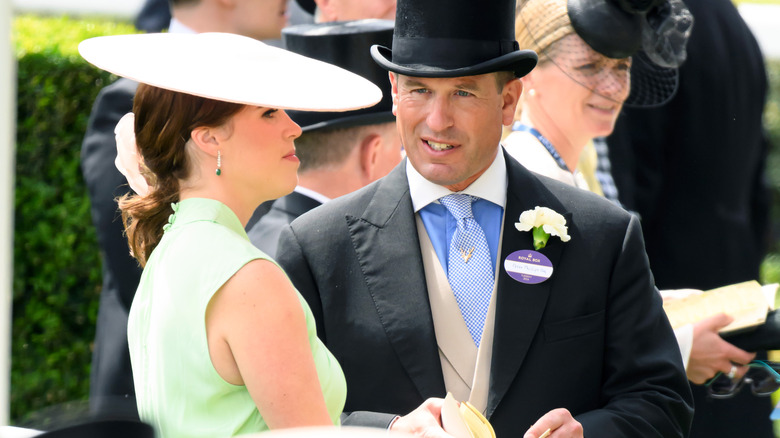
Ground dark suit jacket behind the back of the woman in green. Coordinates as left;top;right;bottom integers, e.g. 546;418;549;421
81;79;141;415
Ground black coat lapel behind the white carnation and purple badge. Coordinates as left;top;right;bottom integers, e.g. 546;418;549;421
487;154;571;418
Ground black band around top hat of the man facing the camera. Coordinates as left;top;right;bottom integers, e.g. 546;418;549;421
392;36;520;69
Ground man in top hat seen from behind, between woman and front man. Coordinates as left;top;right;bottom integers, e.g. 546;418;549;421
247;20;401;257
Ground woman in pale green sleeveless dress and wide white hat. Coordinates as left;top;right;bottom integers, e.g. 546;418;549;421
79;33;444;438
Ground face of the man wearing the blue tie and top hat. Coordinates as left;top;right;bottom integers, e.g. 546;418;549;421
390;73;522;191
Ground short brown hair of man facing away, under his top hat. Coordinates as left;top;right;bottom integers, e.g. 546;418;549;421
295;122;395;172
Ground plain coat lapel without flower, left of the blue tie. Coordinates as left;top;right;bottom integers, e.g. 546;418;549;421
347;161;445;398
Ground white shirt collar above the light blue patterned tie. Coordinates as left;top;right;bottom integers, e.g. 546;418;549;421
406;148;507;213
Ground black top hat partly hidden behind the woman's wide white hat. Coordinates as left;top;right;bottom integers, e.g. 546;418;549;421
282;19;395;132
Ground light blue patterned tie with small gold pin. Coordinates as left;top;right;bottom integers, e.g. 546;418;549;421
439;195;494;347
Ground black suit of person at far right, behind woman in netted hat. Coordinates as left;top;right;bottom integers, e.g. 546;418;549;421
608;0;774;438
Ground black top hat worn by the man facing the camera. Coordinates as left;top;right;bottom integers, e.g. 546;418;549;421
371;0;537;78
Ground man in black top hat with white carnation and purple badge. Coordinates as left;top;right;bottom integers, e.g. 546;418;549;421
278;0;692;438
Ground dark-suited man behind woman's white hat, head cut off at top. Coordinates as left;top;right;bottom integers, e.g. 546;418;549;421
81;0;286;417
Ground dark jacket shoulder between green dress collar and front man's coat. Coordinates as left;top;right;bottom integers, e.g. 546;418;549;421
247;192;322;257
